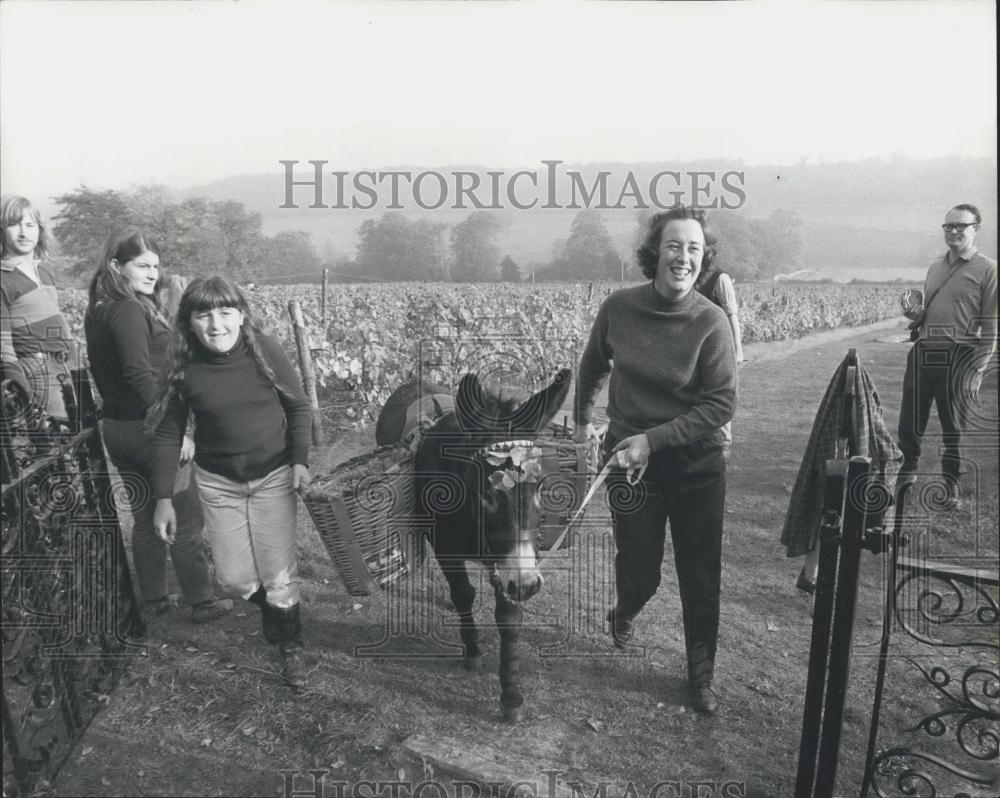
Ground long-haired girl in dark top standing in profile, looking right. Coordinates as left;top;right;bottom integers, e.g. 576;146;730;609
84;231;233;623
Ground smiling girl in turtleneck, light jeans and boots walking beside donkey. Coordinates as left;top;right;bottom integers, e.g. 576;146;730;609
146;277;312;685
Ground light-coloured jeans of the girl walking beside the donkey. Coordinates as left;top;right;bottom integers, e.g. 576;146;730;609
195;464;299;608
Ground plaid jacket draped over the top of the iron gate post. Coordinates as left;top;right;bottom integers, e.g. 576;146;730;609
781;355;903;557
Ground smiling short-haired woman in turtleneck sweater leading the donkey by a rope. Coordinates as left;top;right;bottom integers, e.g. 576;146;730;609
574;206;737;714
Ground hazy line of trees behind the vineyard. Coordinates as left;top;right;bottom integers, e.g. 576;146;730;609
54;186;804;282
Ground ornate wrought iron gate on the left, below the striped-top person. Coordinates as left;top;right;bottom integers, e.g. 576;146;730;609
0;372;144;796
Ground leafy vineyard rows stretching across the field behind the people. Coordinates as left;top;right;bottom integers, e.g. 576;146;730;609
54;283;899;428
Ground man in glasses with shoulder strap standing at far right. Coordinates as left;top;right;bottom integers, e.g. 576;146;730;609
898;205;997;510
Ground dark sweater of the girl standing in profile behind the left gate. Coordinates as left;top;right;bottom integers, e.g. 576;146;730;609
83;299;170;421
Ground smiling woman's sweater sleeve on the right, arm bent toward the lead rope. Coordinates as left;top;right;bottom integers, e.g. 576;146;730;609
646;322;738;452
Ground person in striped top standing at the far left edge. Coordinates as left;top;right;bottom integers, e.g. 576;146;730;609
0;194;79;422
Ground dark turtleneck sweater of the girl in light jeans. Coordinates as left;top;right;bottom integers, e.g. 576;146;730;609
153;328;312;499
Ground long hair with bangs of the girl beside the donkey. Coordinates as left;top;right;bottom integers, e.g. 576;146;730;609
146;276;295;433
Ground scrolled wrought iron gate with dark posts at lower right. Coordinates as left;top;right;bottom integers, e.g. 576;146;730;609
795;468;1000;798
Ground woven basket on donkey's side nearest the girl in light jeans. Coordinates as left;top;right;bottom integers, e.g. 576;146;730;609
304;446;419;596
